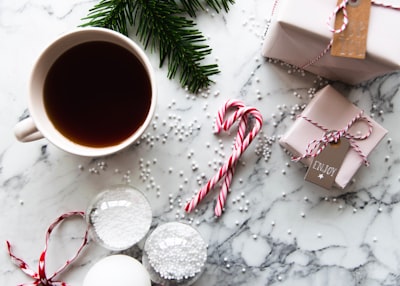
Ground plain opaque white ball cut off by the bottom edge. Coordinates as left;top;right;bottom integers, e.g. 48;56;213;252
83;254;151;286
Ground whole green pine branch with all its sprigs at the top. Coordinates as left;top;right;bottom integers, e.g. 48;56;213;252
82;0;234;93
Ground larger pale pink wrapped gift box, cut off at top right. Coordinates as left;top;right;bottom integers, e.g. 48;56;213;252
262;0;400;84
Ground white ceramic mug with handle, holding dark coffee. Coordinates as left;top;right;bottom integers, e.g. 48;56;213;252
14;28;157;157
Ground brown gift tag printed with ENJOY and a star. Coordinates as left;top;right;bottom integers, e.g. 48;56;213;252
304;138;350;189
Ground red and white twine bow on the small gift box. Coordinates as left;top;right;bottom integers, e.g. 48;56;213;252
292;111;373;166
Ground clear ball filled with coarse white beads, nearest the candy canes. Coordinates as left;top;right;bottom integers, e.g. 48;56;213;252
143;222;207;285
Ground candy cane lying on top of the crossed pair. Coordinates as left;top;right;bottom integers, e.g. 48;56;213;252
185;104;263;216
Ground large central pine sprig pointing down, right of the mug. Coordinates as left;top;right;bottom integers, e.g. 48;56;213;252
136;0;219;92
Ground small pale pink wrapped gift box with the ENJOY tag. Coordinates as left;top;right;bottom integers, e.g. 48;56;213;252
279;85;387;189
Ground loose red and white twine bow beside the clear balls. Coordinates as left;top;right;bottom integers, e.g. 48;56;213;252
6;211;89;286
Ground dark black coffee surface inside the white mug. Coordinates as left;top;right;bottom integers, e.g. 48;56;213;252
44;41;152;147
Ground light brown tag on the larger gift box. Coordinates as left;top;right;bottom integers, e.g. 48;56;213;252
331;0;372;59
